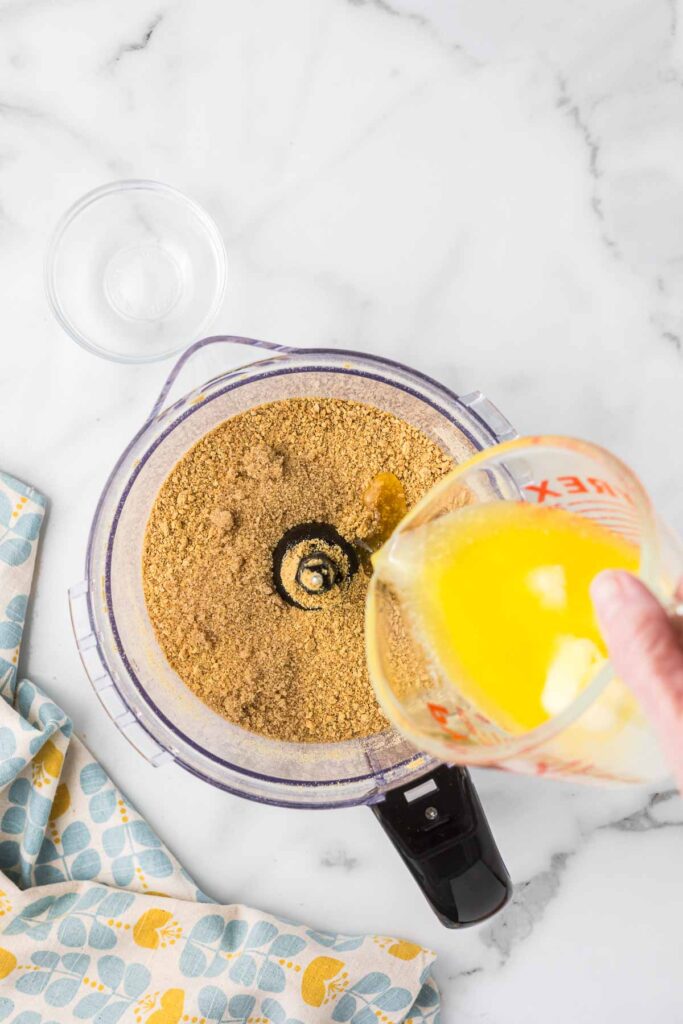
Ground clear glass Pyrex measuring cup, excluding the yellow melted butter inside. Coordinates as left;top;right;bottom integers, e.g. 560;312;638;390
367;436;683;782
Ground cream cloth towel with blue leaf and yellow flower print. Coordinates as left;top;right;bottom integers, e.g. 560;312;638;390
0;473;439;1024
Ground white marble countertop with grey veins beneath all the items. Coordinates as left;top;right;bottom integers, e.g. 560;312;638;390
0;0;683;1024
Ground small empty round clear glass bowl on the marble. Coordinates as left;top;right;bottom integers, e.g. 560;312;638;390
45;180;226;362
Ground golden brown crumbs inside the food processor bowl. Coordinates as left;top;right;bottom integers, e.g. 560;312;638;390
142;398;453;742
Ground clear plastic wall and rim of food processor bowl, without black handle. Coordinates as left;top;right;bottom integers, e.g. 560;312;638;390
70;337;514;807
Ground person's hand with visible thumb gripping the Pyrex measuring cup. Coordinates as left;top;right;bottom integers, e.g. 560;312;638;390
591;569;683;793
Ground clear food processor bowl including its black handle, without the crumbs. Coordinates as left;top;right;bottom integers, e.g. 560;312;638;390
70;336;515;927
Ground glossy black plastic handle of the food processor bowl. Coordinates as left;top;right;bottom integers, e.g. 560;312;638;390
373;765;512;928
